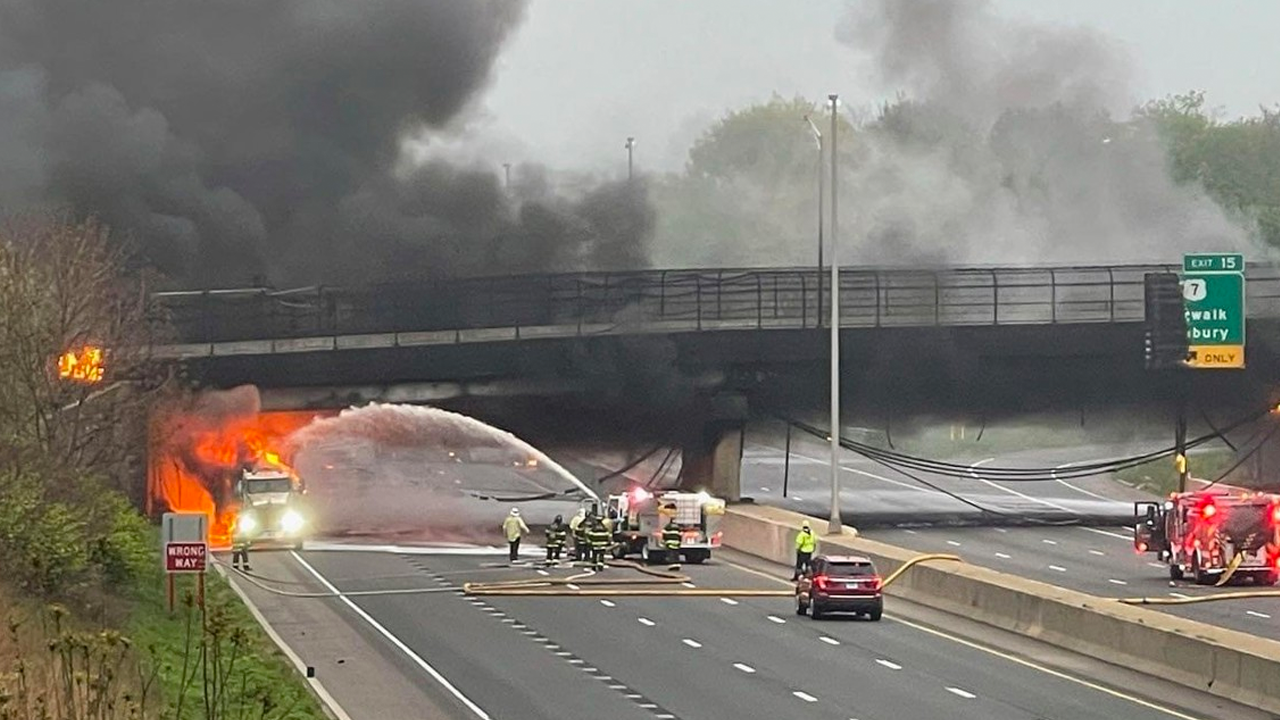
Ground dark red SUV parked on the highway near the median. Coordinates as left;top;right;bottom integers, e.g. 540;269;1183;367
796;555;884;620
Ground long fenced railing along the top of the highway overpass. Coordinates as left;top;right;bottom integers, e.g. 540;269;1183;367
154;265;1280;342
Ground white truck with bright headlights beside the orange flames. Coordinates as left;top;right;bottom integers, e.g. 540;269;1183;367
233;469;308;550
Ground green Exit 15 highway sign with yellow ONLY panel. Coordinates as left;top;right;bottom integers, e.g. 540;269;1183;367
1183;254;1244;368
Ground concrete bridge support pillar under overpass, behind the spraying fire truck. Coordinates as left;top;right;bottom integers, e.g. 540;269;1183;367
680;393;746;502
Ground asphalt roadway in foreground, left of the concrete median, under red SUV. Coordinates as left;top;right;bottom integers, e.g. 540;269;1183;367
227;547;1265;720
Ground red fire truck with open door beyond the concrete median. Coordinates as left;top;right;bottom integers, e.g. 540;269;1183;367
1133;488;1280;584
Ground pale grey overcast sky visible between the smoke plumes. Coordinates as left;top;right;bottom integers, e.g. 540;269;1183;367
468;0;1280;172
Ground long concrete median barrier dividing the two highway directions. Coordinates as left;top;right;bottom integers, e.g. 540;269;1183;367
723;506;1280;714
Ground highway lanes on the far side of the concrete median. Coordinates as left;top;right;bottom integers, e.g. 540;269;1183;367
742;422;1280;639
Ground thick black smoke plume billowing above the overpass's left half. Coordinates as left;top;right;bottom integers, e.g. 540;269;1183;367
0;0;652;286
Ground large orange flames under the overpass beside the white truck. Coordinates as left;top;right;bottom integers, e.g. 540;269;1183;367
148;411;316;547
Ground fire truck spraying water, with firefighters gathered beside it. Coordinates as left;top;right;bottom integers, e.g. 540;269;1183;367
608;487;724;565
